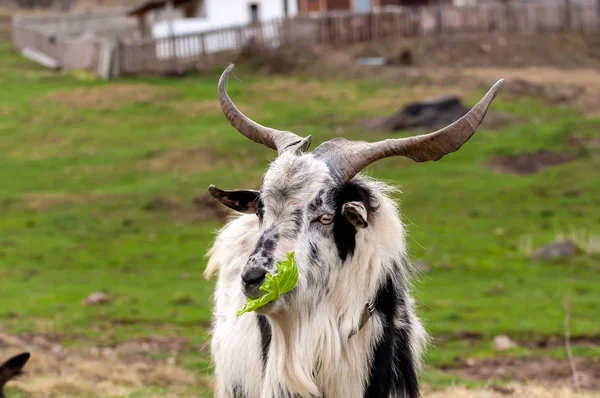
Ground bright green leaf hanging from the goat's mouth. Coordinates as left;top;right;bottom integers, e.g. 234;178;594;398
237;252;298;316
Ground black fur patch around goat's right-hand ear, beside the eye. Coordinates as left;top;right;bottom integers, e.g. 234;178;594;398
333;182;377;261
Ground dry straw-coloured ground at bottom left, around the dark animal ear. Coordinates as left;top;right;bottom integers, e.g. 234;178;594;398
0;335;210;397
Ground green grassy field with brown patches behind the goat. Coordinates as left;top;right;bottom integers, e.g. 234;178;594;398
0;35;600;397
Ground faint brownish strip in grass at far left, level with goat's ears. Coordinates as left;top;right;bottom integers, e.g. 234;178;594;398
23;193;127;210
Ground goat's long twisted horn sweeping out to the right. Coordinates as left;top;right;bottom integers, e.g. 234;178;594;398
313;79;504;182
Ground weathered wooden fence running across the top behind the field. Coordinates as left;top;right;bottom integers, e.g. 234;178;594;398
13;0;600;76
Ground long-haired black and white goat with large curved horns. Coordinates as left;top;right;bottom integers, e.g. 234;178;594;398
205;64;503;398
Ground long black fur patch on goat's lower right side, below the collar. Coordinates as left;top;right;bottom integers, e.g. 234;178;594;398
364;276;419;398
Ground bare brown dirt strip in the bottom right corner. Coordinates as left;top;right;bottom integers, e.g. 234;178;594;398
445;357;600;389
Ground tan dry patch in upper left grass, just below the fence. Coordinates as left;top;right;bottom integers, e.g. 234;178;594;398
44;83;180;110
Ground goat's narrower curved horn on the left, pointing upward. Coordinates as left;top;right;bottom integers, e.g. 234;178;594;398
219;64;310;153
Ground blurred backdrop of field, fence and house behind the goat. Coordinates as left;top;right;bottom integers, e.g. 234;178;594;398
0;0;600;397
